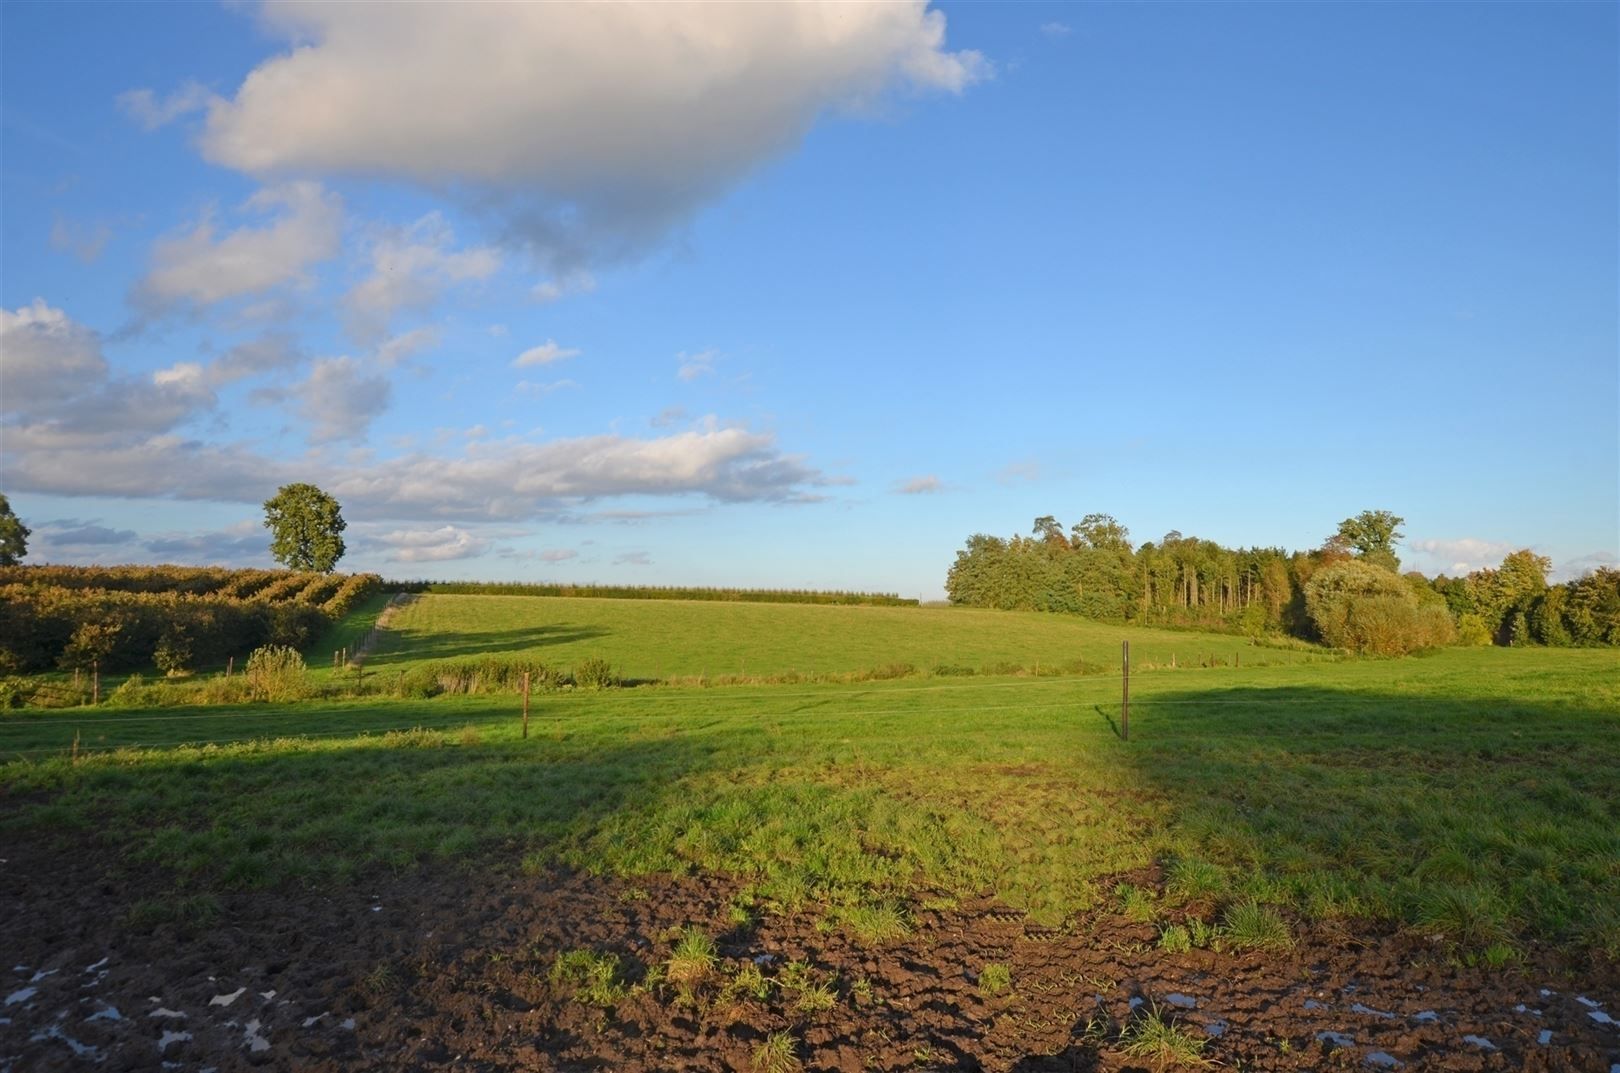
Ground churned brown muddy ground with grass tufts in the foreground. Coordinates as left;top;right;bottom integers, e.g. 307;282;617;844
0;841;1620;1073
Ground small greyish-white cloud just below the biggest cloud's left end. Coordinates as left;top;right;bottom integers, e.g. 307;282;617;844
133;182;343;313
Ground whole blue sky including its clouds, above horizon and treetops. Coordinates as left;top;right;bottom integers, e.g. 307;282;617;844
0;3;1620;598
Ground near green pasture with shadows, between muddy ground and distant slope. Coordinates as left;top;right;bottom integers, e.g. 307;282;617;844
0;638;1620;955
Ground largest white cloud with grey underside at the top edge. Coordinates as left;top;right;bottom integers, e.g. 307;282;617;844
199;0;988;259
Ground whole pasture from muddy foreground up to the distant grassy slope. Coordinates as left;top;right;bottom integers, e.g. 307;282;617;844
0;596;1620;1070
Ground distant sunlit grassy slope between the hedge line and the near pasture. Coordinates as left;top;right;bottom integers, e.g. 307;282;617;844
361;595;1324;679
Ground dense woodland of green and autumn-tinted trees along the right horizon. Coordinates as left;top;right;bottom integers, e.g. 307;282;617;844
946;511;1620;652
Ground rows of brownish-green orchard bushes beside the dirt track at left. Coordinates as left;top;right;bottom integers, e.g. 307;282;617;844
0;566;382;673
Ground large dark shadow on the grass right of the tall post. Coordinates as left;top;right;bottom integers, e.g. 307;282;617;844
1119;682;1620;950
